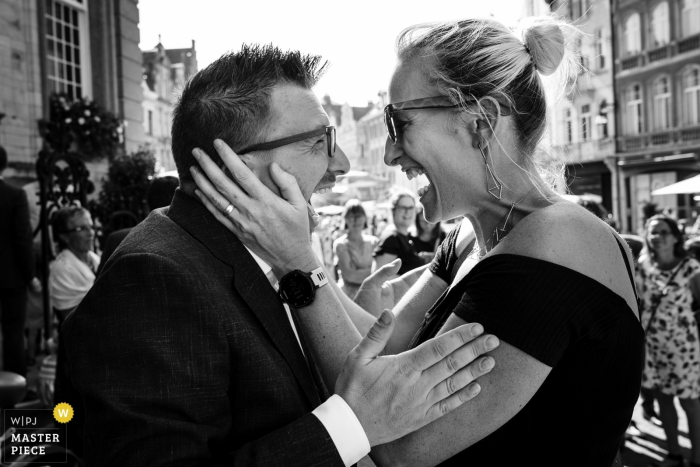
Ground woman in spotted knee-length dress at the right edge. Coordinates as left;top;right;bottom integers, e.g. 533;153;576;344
638;215;700;466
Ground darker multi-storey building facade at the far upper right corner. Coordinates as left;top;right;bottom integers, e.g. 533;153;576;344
613;0;700;231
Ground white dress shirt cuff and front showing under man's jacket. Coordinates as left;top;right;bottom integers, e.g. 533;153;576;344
246;247;371;467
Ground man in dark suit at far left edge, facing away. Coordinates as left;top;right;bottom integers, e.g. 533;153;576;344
0;146;41;376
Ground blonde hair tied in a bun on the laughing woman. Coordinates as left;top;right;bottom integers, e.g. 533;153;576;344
396;15;578;168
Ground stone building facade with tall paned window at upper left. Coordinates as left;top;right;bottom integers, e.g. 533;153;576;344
0;0;145;184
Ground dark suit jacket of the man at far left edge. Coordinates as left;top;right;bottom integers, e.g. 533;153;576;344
0;180;34;289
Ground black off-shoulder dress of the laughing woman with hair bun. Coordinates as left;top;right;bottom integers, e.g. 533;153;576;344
411;235;644;467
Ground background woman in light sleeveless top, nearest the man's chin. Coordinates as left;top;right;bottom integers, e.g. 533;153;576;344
333;199;379;298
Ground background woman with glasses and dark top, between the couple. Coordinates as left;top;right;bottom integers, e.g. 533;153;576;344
372;191;426;275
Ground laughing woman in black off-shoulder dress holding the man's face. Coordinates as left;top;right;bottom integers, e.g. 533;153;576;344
191;17;644;466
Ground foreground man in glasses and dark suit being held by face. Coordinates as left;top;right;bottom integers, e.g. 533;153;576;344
63;46;494;467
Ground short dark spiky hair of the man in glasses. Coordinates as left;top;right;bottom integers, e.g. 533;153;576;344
172;44;327;180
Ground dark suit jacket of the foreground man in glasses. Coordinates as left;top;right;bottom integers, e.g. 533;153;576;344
62;190;343;467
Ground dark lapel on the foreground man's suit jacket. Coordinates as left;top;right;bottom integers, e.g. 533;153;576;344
167;189;321;407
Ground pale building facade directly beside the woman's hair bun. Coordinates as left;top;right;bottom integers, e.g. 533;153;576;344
528;0;617;216
